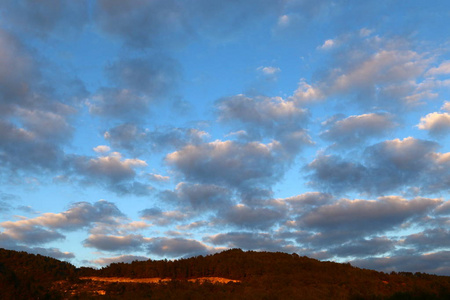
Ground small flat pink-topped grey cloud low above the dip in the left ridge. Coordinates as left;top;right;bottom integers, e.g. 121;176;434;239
83;234;145;251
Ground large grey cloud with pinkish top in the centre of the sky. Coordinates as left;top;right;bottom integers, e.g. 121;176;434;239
166;140;285;190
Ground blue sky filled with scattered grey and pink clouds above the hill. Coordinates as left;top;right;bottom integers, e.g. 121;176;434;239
0;0;450;275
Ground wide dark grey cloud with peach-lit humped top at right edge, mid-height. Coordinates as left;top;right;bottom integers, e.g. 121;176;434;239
307;137;450;194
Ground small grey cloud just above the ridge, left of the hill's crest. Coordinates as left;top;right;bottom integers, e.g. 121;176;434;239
146;237;213;257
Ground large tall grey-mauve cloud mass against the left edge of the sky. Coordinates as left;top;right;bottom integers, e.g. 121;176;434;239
0;29;81;178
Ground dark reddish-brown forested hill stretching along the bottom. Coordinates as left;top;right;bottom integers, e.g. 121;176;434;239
0;249;450;299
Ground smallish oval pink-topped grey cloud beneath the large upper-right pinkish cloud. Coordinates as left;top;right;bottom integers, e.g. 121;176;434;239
320;113;397;147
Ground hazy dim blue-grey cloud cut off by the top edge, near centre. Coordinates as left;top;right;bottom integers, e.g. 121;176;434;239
95;0;285;49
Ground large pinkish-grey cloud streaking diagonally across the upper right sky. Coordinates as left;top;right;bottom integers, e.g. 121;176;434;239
292;32;436;110
